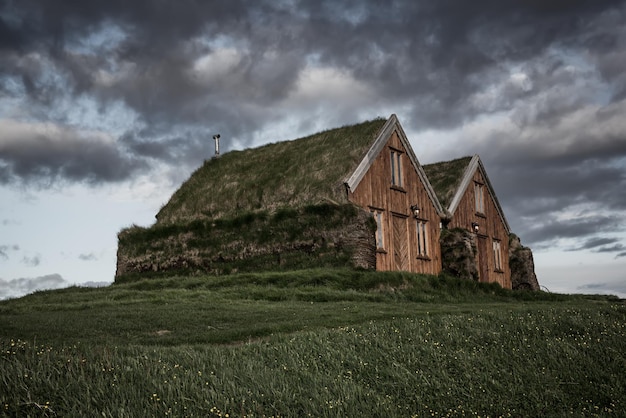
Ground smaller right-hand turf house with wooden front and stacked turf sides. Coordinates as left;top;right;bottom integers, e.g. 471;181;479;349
423;155;539;290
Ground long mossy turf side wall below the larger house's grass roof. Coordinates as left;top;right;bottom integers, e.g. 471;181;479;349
115;204;376;283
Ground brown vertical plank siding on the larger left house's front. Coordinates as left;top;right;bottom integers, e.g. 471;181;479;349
349;131;441;274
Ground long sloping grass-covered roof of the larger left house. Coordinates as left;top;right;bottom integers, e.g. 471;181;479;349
157;118;385;223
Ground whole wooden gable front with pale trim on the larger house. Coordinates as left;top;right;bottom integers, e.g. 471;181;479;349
346;115;444;274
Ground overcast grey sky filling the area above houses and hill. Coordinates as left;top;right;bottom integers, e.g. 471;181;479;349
0;0;626;298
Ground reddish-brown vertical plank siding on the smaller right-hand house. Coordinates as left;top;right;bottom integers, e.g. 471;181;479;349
448;169;511;289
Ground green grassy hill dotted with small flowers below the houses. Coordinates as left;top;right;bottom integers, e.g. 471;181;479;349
0;269;626;417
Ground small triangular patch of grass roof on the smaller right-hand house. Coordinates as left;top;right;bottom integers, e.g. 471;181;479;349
422;157;472;209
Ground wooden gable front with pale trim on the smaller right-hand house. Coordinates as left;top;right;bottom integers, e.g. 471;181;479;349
426;155;511;289
